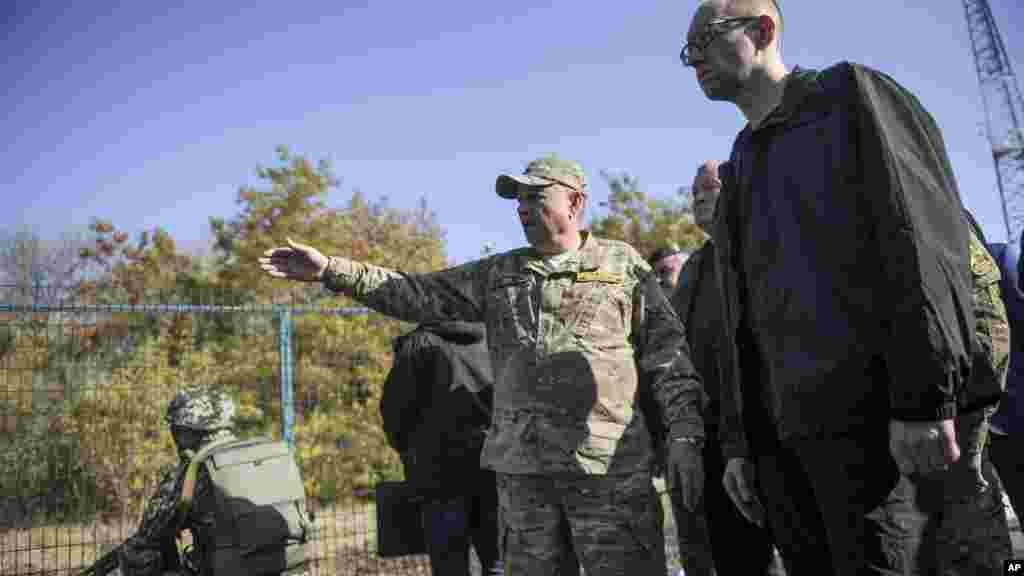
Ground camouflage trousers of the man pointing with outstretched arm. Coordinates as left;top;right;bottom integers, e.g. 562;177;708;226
498;472;666;576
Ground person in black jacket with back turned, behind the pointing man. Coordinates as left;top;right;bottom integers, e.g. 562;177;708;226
380;322;501;576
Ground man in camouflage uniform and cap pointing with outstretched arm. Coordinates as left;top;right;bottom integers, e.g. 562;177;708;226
260;156;703;576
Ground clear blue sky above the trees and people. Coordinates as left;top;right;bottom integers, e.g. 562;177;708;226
0;0;1024;261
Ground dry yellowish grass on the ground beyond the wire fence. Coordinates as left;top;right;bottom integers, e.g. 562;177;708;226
0;502;430;576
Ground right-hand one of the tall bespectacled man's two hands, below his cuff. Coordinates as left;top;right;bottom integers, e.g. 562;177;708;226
889;419;961;476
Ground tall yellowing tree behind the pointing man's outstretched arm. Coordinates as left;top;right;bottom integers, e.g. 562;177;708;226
210;147;446;500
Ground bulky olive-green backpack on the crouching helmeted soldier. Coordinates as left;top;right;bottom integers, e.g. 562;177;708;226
178;438;311;576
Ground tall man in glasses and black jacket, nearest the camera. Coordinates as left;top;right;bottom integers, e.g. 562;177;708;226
681;0;987;576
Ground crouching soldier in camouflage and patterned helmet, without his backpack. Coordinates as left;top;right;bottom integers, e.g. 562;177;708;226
110;385;304;576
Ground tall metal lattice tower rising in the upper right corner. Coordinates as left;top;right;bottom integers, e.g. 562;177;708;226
964;0;1024;242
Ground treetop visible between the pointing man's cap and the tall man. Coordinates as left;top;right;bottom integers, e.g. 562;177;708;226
590;171;705;256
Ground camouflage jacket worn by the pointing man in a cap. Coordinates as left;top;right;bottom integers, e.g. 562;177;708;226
324;233;703;475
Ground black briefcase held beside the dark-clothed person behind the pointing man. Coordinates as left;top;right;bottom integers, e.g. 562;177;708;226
374;482;427;558
